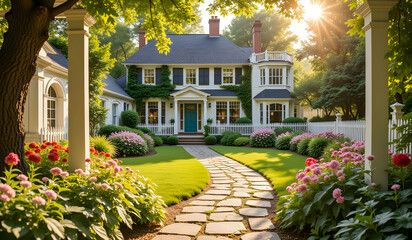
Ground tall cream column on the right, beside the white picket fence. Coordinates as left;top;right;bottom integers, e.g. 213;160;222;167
357;0;396;191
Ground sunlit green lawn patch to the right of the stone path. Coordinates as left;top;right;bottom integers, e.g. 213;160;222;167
210;146;306;196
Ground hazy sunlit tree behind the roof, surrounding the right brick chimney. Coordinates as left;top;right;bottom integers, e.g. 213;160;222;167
223;10;297;51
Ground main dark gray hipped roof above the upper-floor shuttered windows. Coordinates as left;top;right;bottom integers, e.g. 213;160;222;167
124;34;252;64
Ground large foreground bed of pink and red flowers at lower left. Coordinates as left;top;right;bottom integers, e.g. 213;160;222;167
0;142;165;239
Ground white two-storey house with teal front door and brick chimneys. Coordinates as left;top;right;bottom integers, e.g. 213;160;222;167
119;16;300;134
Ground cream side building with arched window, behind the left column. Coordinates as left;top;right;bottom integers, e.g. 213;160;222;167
24;42;135;142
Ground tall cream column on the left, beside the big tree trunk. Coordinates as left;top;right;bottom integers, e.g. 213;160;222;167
65;9;96;172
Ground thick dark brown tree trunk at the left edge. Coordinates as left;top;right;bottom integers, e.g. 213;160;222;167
0;0;54;174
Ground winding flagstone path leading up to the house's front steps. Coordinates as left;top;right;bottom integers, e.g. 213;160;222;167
153;145;280;240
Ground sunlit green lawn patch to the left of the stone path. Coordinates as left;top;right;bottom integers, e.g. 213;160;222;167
121;146;209;205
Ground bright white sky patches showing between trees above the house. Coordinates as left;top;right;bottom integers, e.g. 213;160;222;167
200;0;310;51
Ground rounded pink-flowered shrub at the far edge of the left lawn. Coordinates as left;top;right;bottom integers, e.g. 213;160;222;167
109;132;148;156
